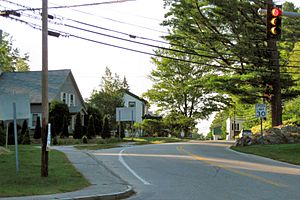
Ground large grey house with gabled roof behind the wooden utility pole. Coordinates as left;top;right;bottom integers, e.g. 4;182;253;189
0;69;86;132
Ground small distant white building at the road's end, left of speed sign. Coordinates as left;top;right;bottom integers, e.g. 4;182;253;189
226;118;244;140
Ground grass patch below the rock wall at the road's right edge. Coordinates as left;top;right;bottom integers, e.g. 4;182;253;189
231;144;300;165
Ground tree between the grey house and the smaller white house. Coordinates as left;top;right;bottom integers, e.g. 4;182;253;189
88;67;129;128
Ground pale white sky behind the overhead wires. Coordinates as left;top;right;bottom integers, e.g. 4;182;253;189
0;0;300;132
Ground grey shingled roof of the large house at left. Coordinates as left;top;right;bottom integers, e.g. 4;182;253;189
0;69;83;108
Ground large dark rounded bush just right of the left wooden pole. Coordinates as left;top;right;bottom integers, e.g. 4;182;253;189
49;101;70;137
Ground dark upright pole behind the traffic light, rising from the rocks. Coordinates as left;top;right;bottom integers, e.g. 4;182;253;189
267;0;282;127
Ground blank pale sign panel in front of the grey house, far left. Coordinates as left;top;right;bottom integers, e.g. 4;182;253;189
0;94;30;121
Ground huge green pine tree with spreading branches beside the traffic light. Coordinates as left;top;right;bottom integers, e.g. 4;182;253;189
163;0;295;126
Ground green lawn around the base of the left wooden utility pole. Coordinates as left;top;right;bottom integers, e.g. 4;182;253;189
0;145;90;197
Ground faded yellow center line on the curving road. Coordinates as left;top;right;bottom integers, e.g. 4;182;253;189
177;145;288;187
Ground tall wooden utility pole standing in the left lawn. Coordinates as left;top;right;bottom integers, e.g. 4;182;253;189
41;0;49;177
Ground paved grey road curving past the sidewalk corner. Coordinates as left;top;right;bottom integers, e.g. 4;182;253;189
93;142;300;200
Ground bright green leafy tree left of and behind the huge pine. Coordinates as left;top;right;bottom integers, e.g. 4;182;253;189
144;47;227;134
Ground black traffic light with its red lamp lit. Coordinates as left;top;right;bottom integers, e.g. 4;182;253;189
267;6;282;39
